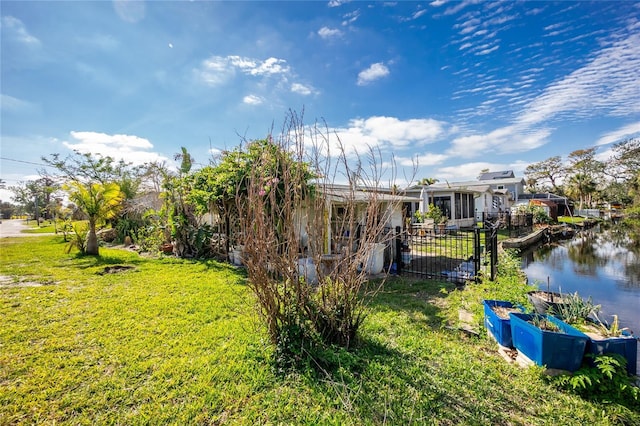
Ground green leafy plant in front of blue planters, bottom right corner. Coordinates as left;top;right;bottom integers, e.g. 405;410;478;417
550;354;640;410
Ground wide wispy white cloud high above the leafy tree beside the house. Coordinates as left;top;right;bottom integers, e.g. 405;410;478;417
195;55;290;86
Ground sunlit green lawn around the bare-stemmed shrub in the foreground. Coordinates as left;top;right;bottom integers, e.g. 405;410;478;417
0;236;640;425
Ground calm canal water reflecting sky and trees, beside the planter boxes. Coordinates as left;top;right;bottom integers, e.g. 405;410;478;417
522;227;640;371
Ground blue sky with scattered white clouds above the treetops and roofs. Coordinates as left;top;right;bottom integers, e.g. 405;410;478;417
0;0;640;200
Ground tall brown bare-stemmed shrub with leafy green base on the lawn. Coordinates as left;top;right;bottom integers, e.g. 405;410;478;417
232;113;412;366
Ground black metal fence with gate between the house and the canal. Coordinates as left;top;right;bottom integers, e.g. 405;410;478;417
394;227;498;283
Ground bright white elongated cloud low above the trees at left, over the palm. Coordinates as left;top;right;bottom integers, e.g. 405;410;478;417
62;131;168;164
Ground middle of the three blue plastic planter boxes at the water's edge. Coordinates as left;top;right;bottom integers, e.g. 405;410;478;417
510;313;589;371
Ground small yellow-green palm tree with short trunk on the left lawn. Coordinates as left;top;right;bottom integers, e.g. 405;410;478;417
67;181;124;256
